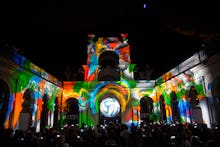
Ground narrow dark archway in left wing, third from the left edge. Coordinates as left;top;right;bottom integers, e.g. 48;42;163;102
40;94;49;132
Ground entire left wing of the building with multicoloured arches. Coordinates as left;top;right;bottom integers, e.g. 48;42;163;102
0;46;62;131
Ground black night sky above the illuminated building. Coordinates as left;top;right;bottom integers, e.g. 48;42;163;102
0;0;220;79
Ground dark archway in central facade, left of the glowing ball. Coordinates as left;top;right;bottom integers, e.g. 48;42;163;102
64;98;79;124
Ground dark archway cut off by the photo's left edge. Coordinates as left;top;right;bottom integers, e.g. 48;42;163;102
0;79;10;125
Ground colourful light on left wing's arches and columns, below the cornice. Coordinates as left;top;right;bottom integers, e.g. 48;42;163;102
10;74;60;131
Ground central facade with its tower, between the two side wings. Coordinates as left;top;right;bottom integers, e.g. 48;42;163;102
62;34;157;125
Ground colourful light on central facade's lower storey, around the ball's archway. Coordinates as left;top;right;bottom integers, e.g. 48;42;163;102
62;80;156;125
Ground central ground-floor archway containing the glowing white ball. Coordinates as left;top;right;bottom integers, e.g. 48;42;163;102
99;93;121;124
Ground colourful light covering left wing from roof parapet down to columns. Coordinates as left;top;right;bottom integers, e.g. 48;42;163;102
0;52;61;131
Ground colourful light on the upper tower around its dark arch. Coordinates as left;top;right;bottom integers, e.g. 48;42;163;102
83;34;131;82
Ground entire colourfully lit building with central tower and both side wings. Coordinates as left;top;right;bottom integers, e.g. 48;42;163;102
0;34;220;131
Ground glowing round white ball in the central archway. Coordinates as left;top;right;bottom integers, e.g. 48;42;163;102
100;97;120;117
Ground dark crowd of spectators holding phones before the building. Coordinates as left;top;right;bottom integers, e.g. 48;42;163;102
0;123;220;147
